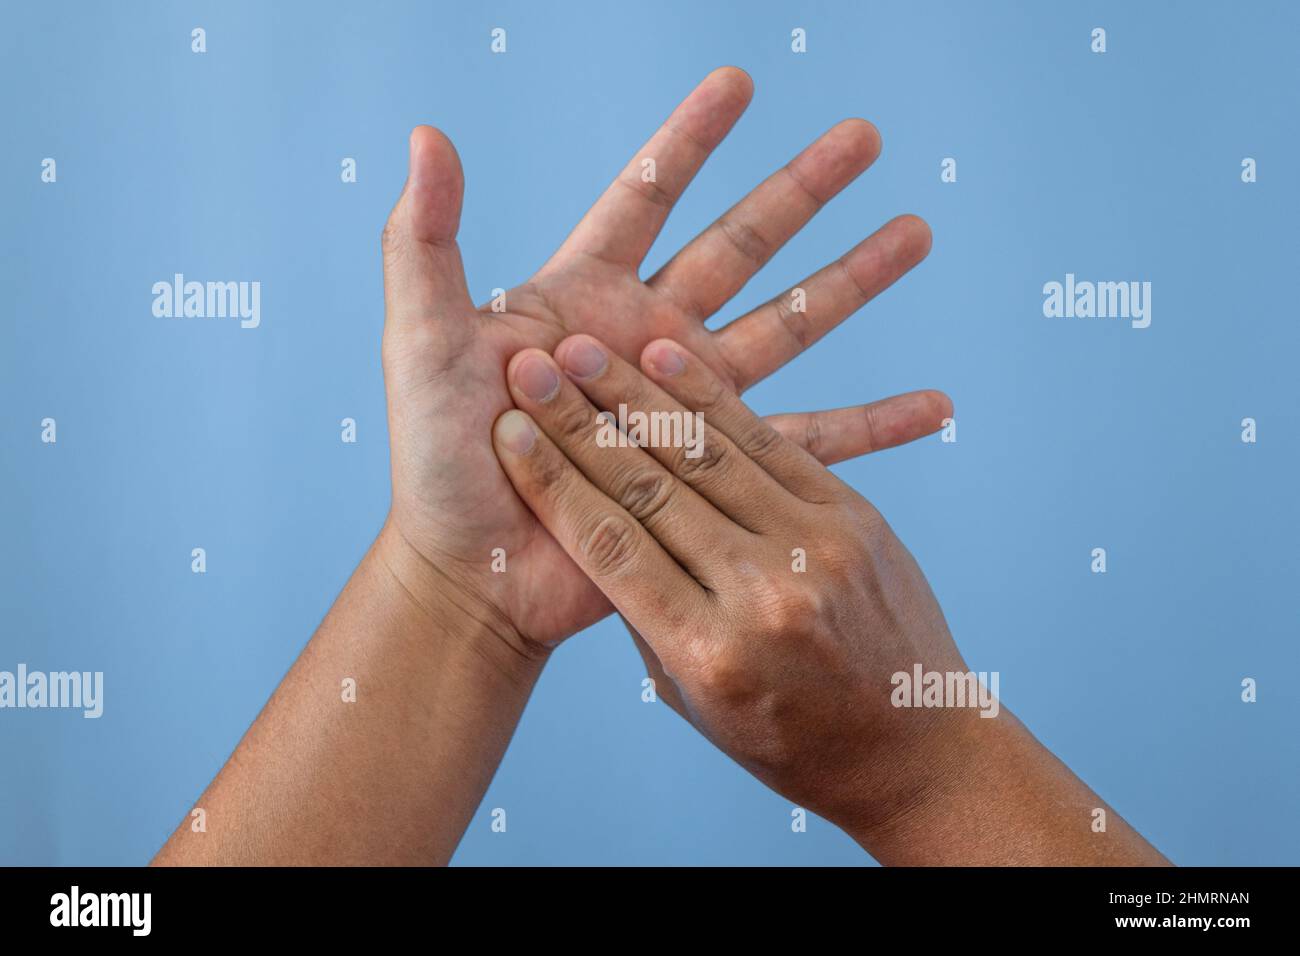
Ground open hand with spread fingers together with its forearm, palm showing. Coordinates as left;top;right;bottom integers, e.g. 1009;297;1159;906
155;68;952;864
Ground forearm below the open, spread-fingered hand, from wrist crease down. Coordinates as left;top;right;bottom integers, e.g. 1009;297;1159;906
153;527;542;865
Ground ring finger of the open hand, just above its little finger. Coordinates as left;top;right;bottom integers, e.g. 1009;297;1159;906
714;216;931;392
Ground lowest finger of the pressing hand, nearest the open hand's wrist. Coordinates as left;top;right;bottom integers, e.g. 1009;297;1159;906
493;408;705;623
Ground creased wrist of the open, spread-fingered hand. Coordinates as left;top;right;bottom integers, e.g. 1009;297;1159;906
372;515;550;685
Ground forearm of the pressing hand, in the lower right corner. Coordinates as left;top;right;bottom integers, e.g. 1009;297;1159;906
845;708;1169;866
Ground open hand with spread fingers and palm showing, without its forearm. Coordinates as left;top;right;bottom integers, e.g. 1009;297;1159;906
380;69;952;656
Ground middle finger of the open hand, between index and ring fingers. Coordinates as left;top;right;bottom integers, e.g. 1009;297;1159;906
647;120;880;321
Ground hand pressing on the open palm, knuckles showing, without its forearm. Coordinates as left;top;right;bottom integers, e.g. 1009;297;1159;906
495;336;966;826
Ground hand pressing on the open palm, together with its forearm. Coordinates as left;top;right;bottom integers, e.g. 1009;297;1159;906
494;336;1166;865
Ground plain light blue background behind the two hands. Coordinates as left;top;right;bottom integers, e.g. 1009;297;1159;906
0;1;1300;864
